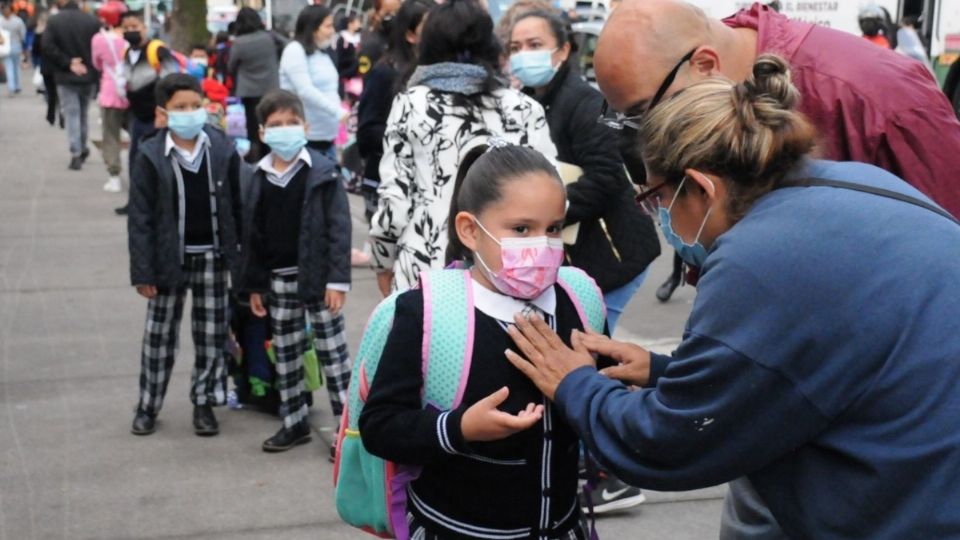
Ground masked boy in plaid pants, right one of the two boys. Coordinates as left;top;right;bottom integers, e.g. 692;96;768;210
243;90;350;452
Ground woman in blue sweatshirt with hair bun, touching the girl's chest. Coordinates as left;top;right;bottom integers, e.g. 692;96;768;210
507;55;960;539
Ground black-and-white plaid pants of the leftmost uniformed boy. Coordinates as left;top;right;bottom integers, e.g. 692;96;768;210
139;251;227;415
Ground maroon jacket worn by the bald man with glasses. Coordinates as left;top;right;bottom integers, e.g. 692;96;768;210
724;4;960;216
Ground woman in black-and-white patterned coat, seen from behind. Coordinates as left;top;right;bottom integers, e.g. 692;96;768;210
370;0;557;295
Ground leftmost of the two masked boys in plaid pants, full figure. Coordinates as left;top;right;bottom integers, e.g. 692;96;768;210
127;73;241;435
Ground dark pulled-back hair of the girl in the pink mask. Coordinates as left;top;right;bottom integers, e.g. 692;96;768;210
446;144;561;264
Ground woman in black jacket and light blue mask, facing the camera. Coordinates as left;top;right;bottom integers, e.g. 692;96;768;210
509;11;660;332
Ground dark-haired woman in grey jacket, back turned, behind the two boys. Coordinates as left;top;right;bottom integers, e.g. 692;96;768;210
227;7;280;163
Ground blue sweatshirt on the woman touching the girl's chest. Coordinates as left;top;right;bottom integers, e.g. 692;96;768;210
555;161;960;539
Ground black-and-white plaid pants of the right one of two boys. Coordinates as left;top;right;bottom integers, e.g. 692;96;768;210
267;273;350;428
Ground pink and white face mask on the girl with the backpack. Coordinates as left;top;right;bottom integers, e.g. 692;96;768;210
474;219;563;300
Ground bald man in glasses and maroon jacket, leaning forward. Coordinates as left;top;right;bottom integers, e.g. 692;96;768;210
594;0;960;216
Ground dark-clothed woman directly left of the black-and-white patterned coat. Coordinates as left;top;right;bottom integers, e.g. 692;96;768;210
357;0;434;220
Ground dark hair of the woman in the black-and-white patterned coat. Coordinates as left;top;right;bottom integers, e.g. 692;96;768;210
417;0;503;93
